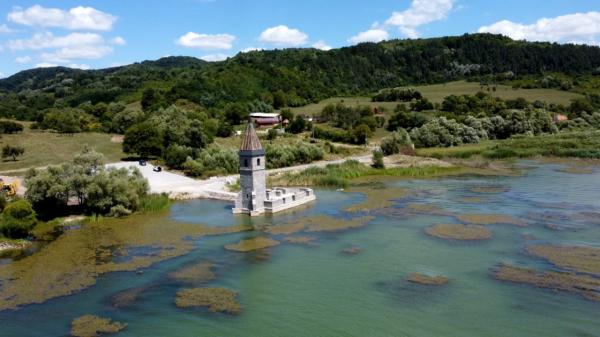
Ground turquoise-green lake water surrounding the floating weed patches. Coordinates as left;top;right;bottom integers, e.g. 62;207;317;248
0;163;600;337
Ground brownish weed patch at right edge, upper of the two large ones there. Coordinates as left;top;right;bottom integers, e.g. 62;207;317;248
527;245;600;275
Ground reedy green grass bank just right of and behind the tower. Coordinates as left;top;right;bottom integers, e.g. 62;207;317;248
269;160;470;188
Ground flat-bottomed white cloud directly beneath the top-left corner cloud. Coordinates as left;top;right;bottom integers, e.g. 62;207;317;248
8;32;105;50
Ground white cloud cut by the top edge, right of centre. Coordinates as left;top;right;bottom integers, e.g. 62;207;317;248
385;0;454;38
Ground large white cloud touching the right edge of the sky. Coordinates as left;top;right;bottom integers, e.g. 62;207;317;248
479;12;600;44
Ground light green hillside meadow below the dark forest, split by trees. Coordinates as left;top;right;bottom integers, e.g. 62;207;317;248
292;81;582;116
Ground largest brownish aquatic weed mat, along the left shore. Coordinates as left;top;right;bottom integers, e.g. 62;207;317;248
0;215;245;311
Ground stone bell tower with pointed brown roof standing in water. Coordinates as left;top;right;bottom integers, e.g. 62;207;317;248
233;122;267;216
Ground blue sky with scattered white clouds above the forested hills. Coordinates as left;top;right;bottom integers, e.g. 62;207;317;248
0;0;600;77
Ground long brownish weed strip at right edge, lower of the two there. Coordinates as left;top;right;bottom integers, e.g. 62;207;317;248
494;264;600;302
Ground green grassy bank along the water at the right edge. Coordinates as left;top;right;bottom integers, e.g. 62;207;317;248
417;131;600;159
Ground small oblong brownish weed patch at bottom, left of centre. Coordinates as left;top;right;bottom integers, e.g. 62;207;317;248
175;288;242;315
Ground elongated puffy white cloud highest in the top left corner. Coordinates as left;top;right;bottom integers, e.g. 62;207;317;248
8;5;117;31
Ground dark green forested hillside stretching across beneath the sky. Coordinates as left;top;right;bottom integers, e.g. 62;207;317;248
0;34;600;122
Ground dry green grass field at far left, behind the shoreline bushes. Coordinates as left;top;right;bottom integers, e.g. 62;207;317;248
0;123;124;172
